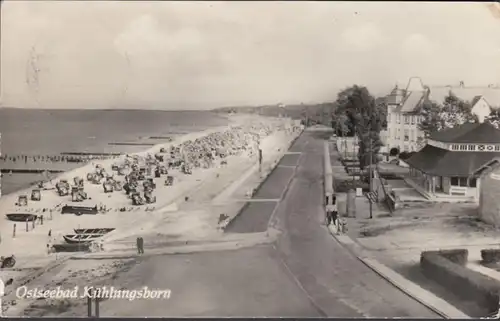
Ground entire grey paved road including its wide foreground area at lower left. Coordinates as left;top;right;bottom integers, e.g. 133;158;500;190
97;132;439;318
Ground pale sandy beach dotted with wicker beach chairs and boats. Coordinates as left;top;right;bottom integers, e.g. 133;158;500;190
0;115;302;316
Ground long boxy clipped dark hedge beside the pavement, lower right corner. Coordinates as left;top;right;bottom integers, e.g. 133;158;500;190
420;249;500;315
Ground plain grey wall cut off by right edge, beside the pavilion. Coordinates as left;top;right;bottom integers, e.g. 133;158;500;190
479;168;500;227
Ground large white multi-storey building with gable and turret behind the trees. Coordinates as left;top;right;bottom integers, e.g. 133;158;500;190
381;77;500;153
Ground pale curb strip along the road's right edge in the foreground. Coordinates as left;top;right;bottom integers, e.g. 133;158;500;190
328;226;471;319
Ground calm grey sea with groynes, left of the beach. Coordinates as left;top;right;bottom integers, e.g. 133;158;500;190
0;108;229;195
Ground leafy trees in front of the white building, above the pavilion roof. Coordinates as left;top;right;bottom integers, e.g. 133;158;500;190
419;92;477;138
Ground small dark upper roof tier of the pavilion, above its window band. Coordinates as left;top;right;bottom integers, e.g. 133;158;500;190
429;122;500;144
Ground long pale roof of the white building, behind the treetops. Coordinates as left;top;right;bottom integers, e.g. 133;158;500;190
429;86;500;108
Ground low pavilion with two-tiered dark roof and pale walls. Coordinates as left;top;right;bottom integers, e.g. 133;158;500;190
406;122;500;202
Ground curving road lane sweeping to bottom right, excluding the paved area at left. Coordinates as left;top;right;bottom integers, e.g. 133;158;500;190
276;132;440;318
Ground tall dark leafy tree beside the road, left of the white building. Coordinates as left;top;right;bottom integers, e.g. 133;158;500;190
337;85;385;169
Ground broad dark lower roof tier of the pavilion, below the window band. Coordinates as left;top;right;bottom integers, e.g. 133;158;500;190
405;145;500;177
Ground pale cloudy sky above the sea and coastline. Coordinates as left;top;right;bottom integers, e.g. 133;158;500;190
0;0;500;109
